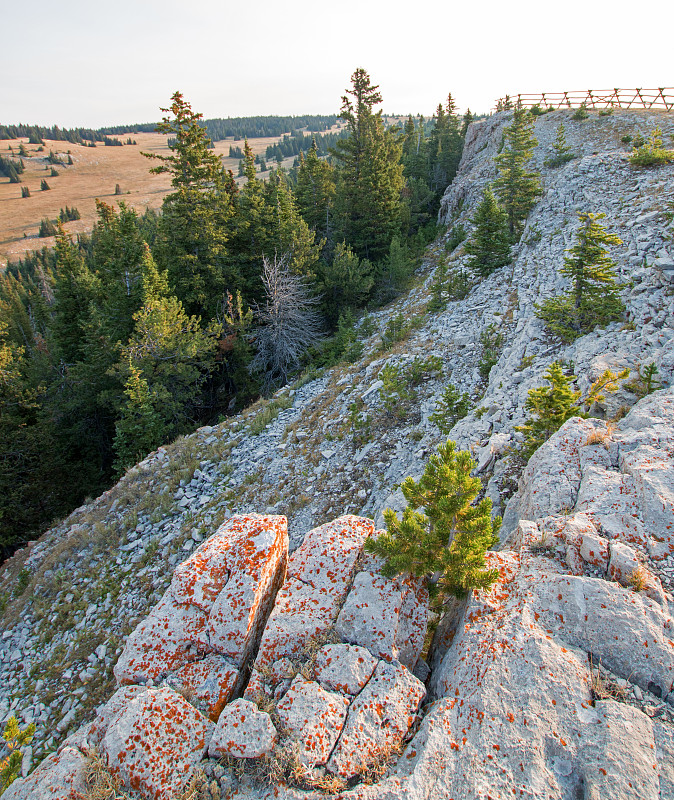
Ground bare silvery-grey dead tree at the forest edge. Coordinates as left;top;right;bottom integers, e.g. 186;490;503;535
250;254;321;393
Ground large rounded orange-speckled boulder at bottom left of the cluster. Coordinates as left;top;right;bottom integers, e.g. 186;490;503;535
100;686;213;800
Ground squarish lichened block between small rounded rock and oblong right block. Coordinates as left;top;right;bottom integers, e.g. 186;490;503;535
277;675;349;767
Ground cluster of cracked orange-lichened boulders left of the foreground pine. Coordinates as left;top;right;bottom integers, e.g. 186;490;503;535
3;515;428;800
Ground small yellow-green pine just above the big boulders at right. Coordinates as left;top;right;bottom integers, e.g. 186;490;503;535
516;361;581;459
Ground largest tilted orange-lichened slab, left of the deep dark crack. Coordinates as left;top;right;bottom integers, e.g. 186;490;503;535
114;514;288;684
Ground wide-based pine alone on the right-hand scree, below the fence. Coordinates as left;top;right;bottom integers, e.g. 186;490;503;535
536;213;625;341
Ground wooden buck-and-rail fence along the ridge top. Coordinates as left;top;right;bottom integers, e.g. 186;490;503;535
496;87;674;111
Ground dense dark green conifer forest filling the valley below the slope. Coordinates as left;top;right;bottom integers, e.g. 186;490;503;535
0;69;470;556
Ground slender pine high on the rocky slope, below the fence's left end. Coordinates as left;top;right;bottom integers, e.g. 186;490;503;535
494;107;541;237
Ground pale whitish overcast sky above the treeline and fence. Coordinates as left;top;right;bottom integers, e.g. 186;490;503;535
0;0;674;128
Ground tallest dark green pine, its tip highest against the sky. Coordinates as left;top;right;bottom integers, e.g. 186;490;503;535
334;68;403;261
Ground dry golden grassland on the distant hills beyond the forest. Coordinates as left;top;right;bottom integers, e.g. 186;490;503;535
0;133;293;269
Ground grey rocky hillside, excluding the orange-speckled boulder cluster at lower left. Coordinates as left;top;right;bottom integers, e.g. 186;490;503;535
0;111;674;798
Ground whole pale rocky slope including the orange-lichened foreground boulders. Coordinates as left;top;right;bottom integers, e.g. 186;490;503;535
0;110;674;800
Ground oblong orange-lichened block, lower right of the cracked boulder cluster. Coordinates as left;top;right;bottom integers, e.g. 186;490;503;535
328;661;426;778
